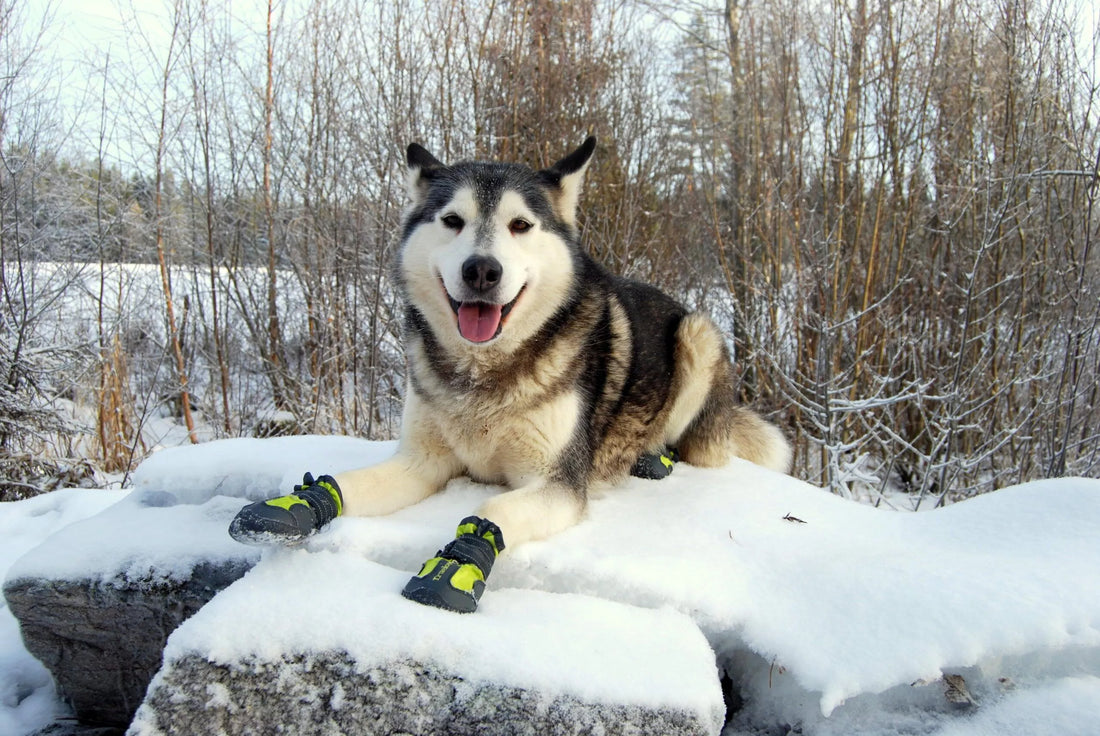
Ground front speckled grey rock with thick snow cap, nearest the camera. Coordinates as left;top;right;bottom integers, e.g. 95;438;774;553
129;550;724;736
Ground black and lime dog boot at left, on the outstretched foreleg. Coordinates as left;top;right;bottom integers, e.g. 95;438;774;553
229;473;343;545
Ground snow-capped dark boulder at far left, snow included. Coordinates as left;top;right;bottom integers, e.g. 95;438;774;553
3;493;259;728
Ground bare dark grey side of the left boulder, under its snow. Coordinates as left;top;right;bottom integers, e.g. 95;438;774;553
3;560;251;728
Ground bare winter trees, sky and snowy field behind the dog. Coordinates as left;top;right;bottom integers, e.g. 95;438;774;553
0;0;1100;505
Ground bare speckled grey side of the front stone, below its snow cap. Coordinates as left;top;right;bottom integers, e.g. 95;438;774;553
128;652;716;736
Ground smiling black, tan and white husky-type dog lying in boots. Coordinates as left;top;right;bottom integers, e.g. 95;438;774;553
231;138;791;612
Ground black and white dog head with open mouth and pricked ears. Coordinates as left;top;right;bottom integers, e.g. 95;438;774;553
397;138;595;352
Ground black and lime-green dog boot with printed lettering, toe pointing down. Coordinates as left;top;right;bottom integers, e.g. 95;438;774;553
402;516;504;613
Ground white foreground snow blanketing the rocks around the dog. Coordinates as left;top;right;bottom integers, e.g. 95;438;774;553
0;437;1100;736
